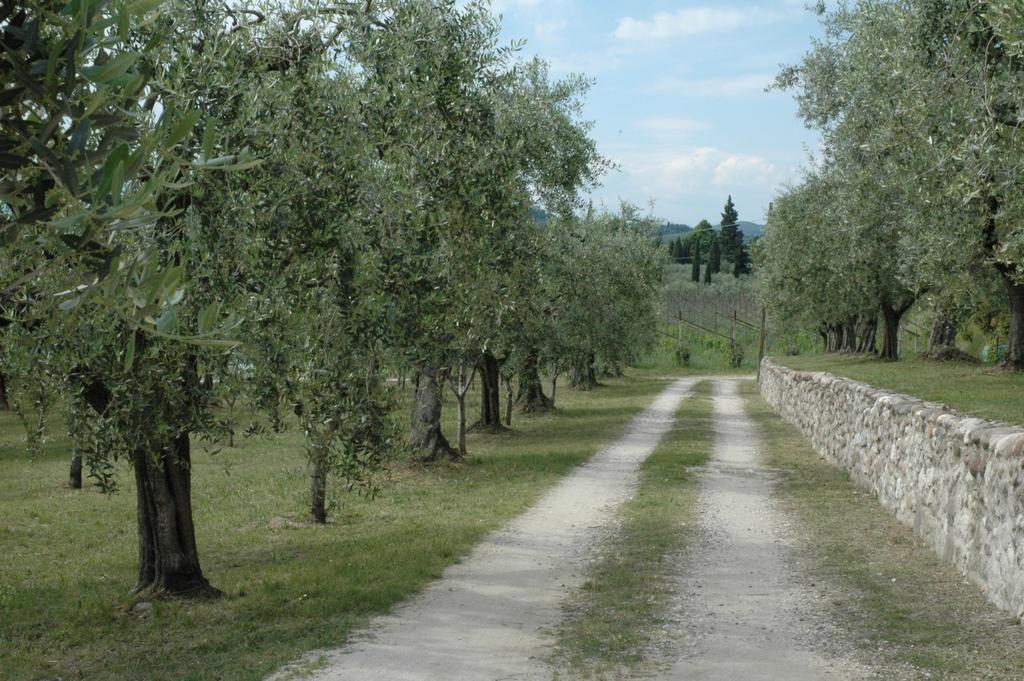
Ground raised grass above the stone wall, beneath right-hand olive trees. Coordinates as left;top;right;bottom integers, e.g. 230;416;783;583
773;354;1024;424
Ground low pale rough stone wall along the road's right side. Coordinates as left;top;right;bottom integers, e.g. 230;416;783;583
761;358;1024;616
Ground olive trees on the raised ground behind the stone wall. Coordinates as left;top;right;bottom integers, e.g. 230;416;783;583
756;0;1024;371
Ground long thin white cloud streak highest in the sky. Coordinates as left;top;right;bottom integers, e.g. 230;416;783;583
614;6;779;43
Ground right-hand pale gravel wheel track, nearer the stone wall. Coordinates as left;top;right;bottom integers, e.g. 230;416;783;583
662;380;866;681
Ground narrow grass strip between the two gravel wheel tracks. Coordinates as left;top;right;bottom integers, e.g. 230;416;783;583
553;381;713;679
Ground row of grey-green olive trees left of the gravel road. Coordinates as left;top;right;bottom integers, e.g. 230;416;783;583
0;0;665;595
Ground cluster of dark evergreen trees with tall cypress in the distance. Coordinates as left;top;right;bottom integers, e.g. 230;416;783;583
669;196;751;284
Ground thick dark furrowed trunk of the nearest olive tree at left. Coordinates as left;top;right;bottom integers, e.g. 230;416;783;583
132;433;220;596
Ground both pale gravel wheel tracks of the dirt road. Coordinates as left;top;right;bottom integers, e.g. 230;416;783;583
273;378;869;681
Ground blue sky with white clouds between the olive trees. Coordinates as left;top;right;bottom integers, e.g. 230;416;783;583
493;0;820;224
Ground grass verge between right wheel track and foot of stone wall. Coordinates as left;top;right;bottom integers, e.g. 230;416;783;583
742;383;1024;681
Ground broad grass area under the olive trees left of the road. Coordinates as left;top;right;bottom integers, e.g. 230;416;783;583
0;377;679;681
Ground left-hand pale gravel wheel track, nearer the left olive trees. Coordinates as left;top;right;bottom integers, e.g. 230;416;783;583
273;379;695;681
